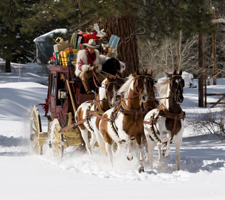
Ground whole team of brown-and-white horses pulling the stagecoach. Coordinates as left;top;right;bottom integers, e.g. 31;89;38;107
75;70;185;172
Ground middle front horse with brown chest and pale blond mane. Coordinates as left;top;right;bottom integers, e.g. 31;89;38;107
100;73;156;172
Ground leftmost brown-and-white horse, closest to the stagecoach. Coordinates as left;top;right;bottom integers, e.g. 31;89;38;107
75;76;119;154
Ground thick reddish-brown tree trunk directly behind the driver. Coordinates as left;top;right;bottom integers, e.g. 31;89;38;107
104;16;139;76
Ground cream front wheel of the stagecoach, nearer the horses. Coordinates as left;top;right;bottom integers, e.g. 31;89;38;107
49;119;64;159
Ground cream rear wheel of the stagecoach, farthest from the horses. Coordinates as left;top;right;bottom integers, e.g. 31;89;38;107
30;106;43;155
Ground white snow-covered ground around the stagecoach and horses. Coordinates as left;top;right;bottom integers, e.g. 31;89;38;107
0;63;225;200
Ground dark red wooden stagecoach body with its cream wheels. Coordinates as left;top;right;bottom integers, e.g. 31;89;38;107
30;54;125;157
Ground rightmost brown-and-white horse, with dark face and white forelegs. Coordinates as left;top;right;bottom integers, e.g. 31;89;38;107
144;70;185;170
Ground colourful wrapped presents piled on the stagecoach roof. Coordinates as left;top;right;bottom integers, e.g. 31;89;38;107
51;24;120;66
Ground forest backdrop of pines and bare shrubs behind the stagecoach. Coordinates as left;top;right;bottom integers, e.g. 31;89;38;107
0;0;225;77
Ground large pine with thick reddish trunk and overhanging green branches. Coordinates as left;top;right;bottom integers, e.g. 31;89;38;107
80;0;219;73
